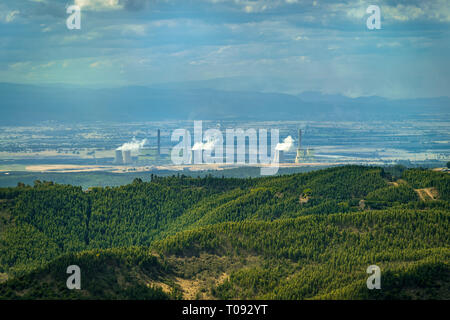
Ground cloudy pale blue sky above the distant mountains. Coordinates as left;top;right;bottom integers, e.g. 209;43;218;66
0;0;450;98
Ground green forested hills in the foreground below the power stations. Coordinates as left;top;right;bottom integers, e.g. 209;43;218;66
0;166;450;299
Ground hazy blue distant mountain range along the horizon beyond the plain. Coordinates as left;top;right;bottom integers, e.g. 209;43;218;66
0;82;450;125
